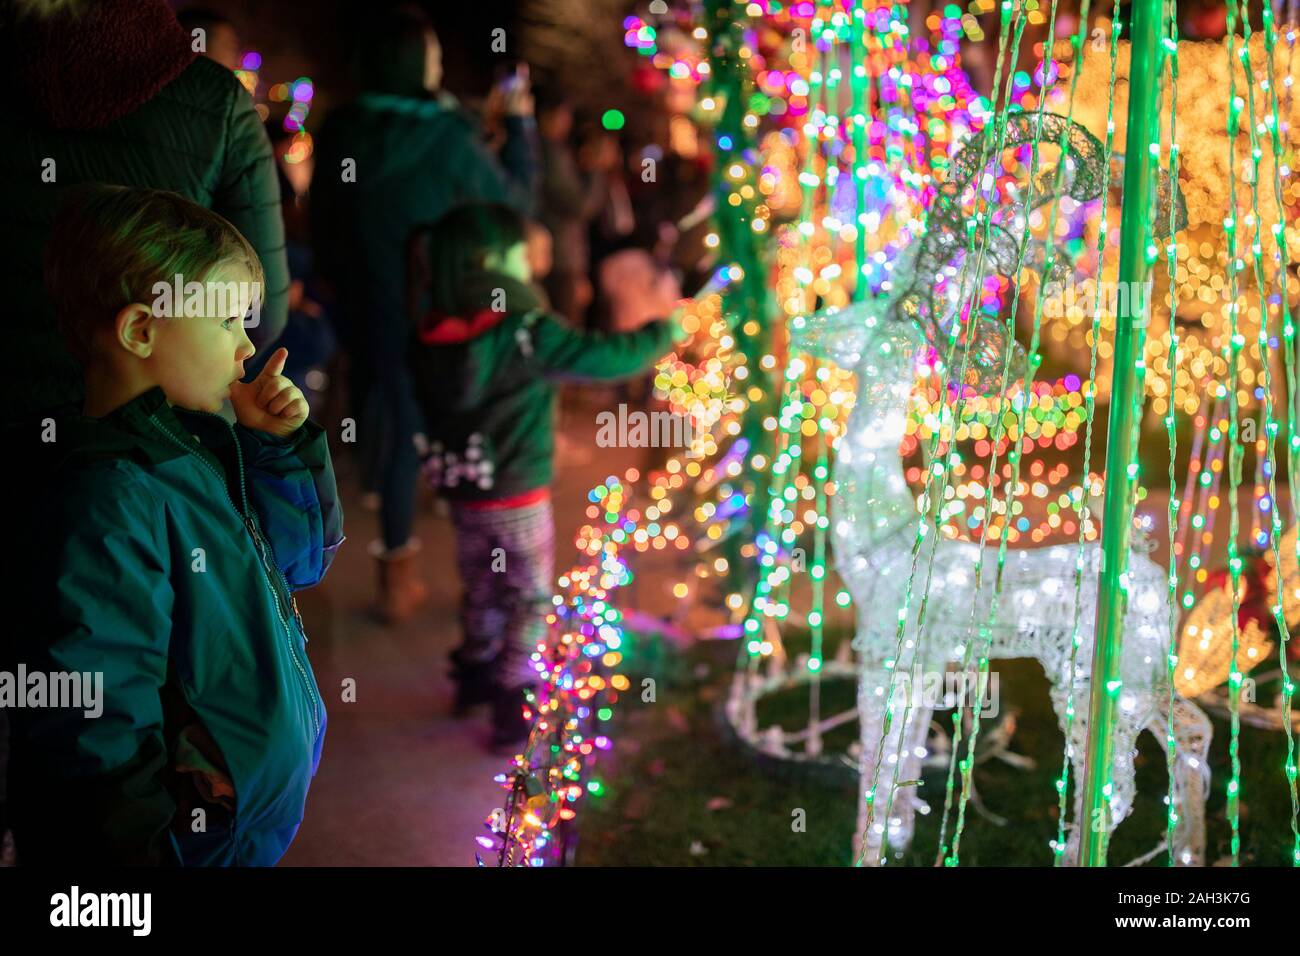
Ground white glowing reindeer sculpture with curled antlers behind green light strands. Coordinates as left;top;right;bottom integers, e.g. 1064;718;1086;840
792;114;1210;865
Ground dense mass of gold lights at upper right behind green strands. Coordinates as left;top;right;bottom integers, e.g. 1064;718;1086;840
1044;34;1300;416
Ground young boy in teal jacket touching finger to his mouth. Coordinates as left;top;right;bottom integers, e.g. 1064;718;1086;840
10;186;343;865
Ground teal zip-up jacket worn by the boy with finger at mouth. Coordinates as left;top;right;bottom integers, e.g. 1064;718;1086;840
10;389;343;865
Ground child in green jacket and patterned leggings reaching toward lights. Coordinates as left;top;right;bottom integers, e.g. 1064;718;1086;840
410;203;686;748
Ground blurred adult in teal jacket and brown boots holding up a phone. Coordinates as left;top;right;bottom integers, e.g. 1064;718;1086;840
311;0;536;624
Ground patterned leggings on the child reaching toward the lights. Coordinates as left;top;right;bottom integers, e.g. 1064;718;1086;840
451;499;555;688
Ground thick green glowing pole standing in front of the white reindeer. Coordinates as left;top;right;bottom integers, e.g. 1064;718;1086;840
1078;0;1161;866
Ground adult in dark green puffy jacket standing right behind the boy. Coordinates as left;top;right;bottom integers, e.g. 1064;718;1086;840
0;0;289;423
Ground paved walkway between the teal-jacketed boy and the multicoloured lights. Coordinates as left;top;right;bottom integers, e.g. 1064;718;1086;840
281;398;644;866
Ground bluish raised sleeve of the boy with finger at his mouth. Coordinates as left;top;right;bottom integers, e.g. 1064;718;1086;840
235;421;343;591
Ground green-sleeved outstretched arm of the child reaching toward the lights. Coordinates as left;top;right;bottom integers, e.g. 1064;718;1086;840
532;306;685;381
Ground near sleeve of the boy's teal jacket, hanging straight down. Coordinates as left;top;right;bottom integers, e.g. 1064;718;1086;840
19;463;181;865
